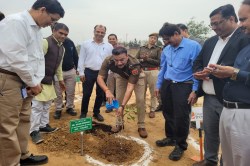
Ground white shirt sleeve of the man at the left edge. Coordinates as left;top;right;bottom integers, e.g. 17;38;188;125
0;20;38;87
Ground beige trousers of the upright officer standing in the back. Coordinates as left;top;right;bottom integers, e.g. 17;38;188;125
144;70;159;112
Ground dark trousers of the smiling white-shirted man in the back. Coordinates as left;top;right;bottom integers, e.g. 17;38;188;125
81;68;104;115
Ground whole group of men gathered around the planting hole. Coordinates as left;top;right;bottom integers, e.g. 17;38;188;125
0;0;250;166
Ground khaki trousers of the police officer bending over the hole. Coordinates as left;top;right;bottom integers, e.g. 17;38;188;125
115;73;145;128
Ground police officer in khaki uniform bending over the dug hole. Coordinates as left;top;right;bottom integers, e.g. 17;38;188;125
97;47;148;138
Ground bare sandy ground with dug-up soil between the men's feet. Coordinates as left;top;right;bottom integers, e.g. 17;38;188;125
29;83;205;166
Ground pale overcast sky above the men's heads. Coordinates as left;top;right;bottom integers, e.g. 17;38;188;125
0;0;242;45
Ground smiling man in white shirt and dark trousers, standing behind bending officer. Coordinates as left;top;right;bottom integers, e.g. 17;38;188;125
78;25;113;121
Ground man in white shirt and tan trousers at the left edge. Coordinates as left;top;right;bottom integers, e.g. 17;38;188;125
0;0;64;166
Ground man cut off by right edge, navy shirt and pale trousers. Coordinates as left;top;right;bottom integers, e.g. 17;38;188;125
205;0;250;166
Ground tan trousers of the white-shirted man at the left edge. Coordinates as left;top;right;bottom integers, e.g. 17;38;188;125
0;73;32;166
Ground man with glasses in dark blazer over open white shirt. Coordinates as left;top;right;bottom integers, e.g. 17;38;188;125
193;4;249;166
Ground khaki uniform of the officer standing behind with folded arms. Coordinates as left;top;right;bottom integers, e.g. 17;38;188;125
136;45;161;112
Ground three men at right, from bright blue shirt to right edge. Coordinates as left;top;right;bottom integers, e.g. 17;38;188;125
152;0;250;166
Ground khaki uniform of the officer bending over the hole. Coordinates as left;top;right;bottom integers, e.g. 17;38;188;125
99;55;145;128
